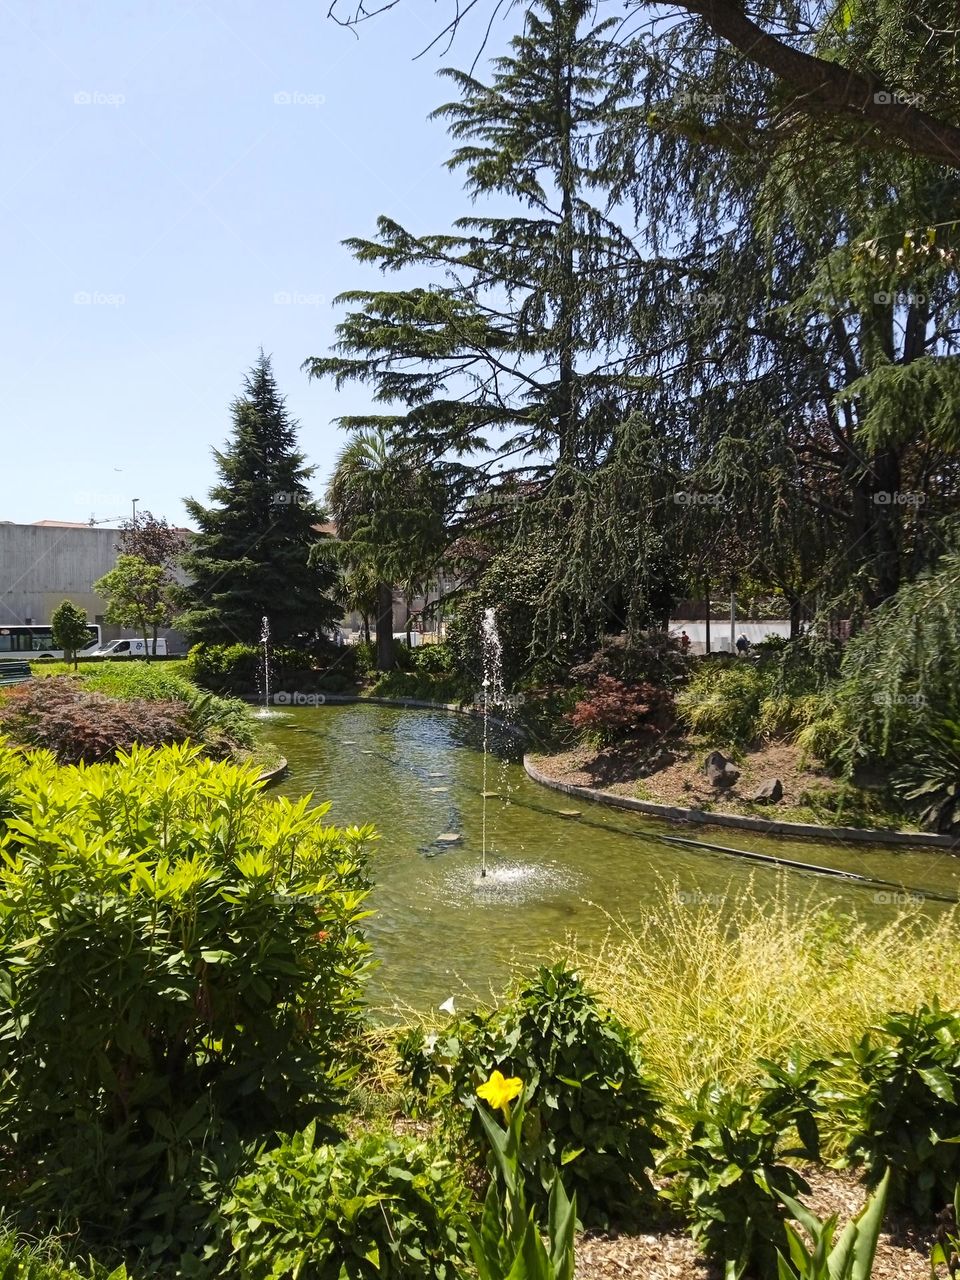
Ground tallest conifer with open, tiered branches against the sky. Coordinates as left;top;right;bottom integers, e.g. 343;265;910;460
305;0;644;471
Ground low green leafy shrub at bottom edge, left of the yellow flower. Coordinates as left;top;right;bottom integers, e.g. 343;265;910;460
223;1125;466;1280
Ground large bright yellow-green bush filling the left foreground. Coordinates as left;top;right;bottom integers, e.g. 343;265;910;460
0;748;371;1254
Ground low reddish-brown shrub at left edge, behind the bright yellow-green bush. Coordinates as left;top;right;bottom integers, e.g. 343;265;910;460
0;676;191;764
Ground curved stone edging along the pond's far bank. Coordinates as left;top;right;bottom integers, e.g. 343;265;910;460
276;694;960;851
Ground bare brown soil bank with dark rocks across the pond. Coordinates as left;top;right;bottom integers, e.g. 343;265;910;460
536;740;855;818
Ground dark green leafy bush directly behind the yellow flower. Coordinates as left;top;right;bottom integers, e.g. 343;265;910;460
401;965;662;1224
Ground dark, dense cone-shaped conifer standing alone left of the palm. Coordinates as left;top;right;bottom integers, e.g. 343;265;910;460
179;351;338;644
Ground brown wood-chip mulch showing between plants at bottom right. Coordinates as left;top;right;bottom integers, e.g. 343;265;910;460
576;1169;946;1280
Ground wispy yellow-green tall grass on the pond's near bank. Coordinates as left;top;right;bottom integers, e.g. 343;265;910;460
566;882;960;1102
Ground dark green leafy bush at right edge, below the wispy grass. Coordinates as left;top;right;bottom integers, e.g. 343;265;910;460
837;1004;960;1219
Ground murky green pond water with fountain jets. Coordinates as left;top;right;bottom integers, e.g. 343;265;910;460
264;704;960;1010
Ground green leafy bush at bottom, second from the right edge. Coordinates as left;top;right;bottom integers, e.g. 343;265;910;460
660;1061;824;1276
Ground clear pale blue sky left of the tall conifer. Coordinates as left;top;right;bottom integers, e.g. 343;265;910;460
0;0;506;522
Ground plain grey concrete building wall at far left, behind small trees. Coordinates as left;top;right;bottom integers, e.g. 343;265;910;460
0;521;184;652
